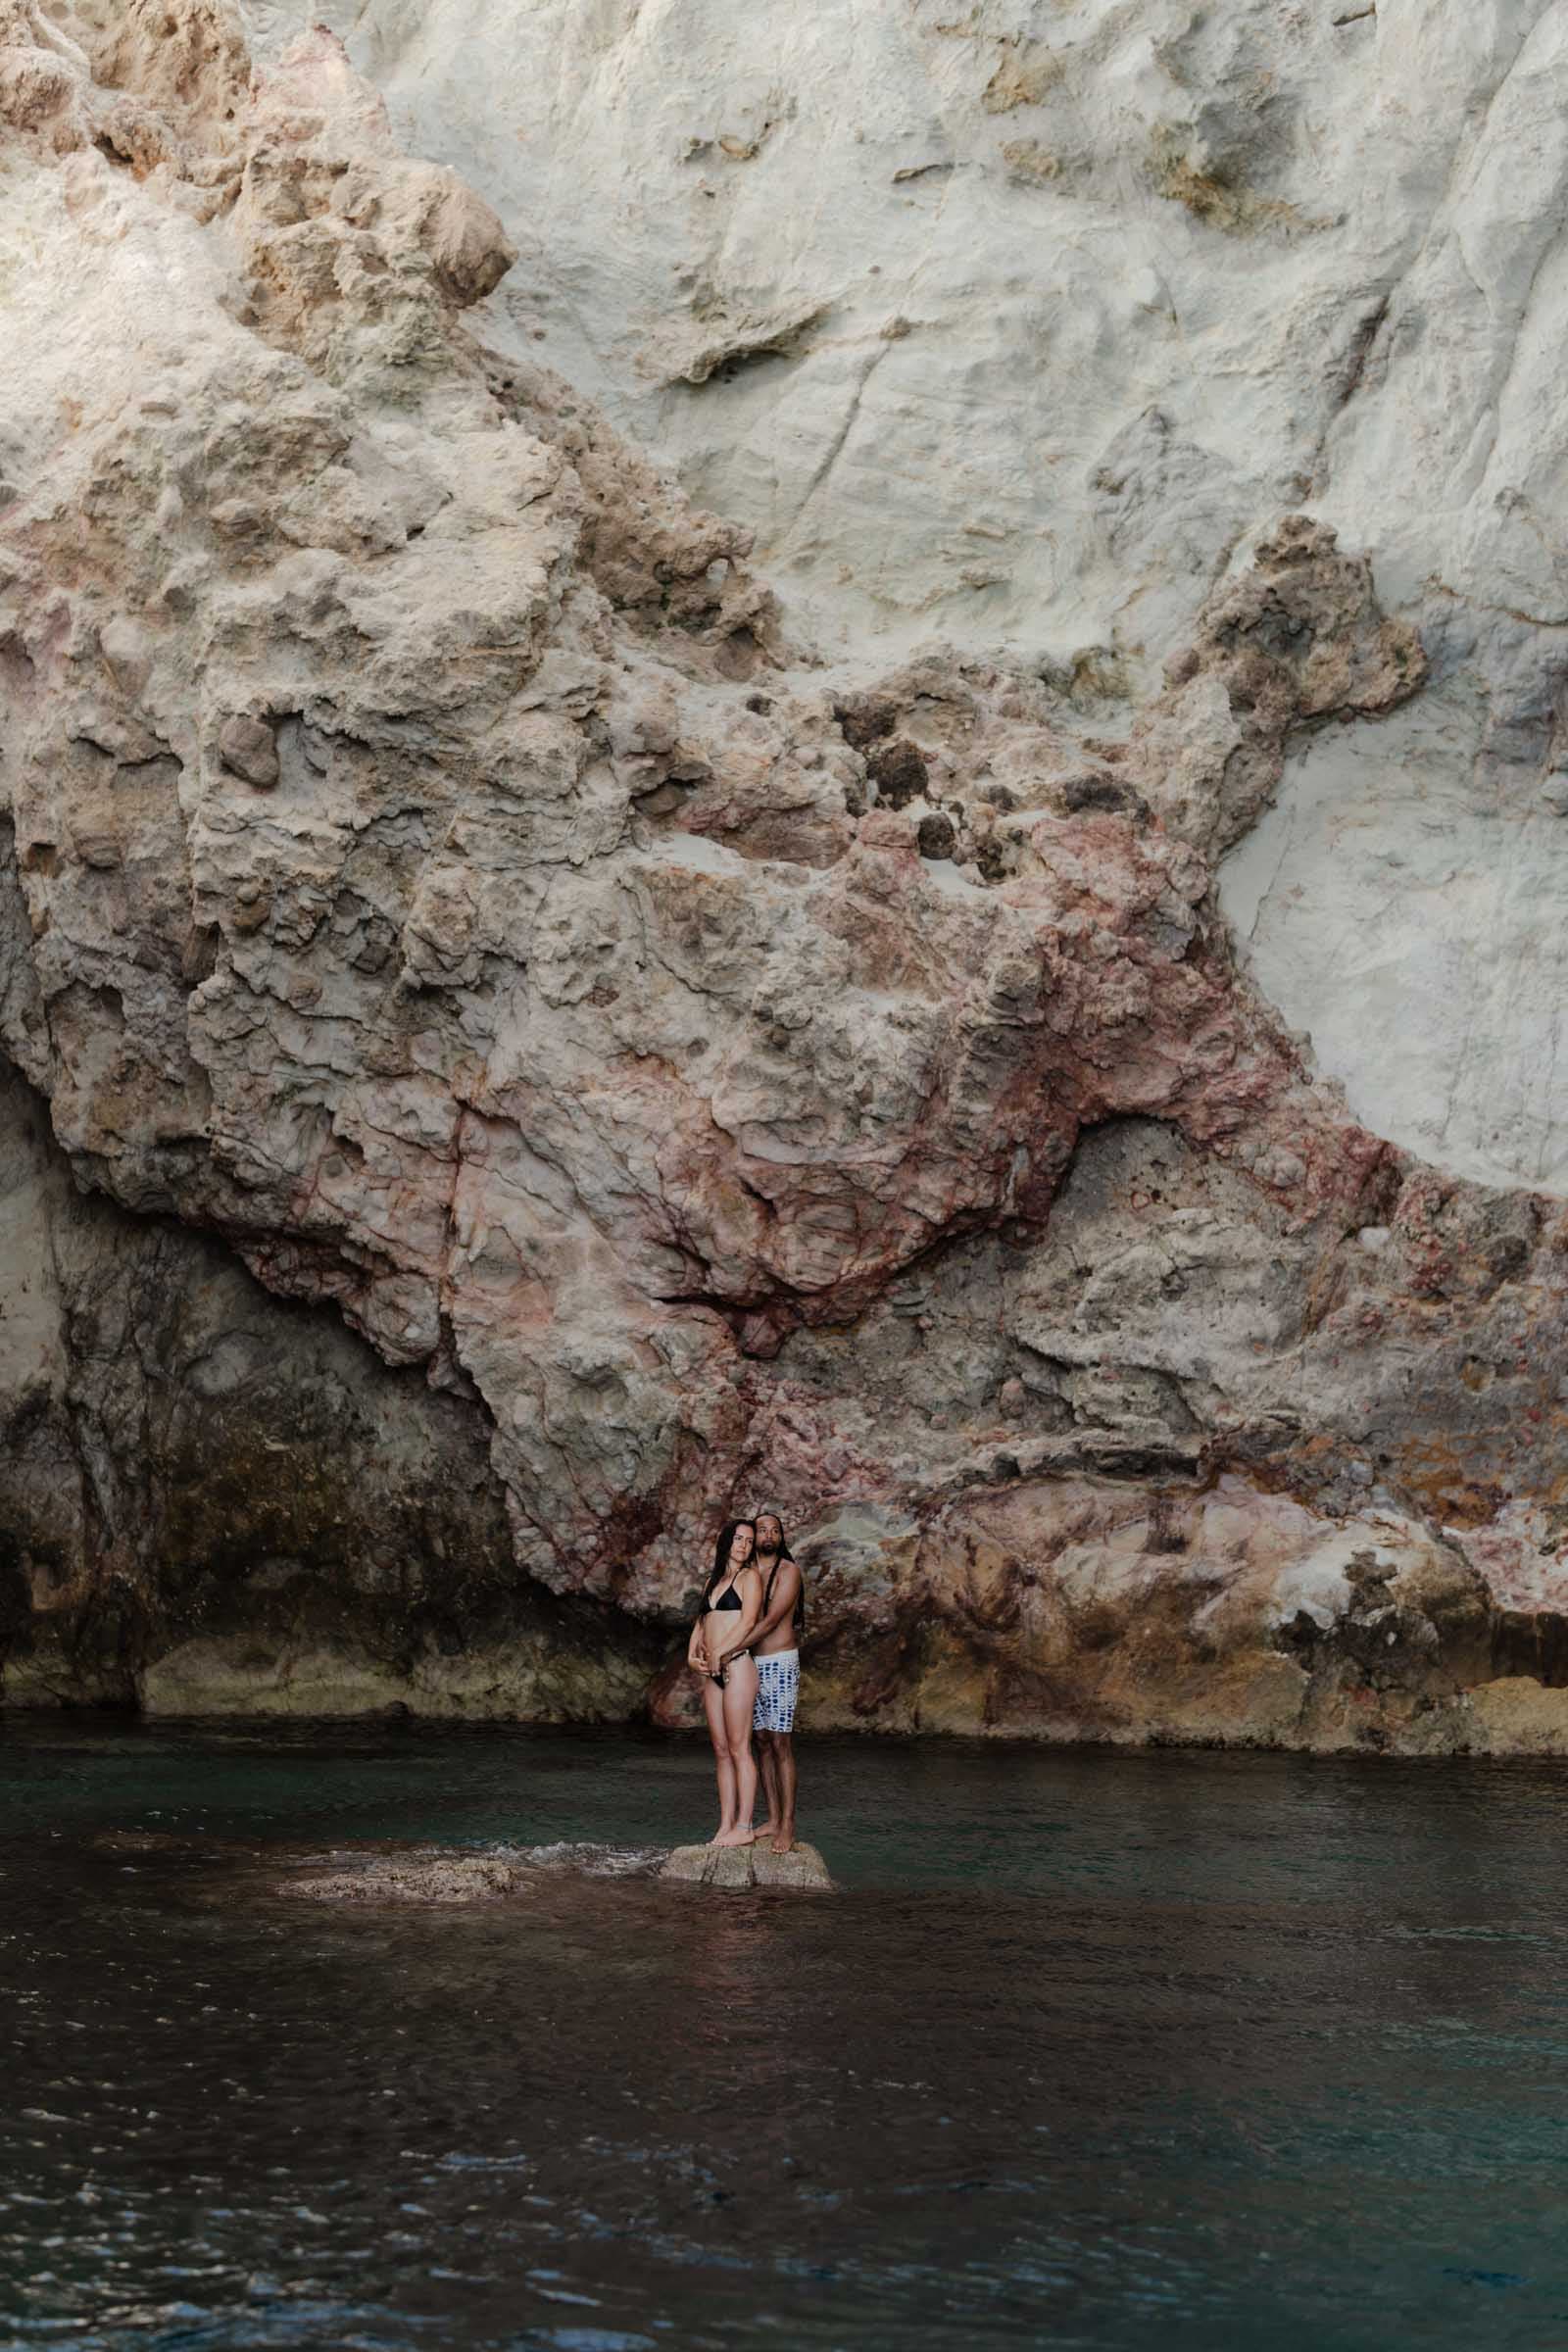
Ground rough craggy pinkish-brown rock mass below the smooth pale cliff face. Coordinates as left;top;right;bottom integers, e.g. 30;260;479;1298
0;0;1568;1745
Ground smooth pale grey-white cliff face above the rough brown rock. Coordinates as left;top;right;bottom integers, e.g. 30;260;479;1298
222;0;1568;1193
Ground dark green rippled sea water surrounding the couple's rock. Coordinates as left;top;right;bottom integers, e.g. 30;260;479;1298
0;1719;1568;2352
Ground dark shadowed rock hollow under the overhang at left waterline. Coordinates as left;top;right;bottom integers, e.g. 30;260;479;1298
0;1075;662;1722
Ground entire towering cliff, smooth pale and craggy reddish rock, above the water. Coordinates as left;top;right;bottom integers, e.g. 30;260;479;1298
0;0;1568;1747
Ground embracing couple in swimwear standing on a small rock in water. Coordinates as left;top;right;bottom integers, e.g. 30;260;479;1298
686;1510;807;1853
